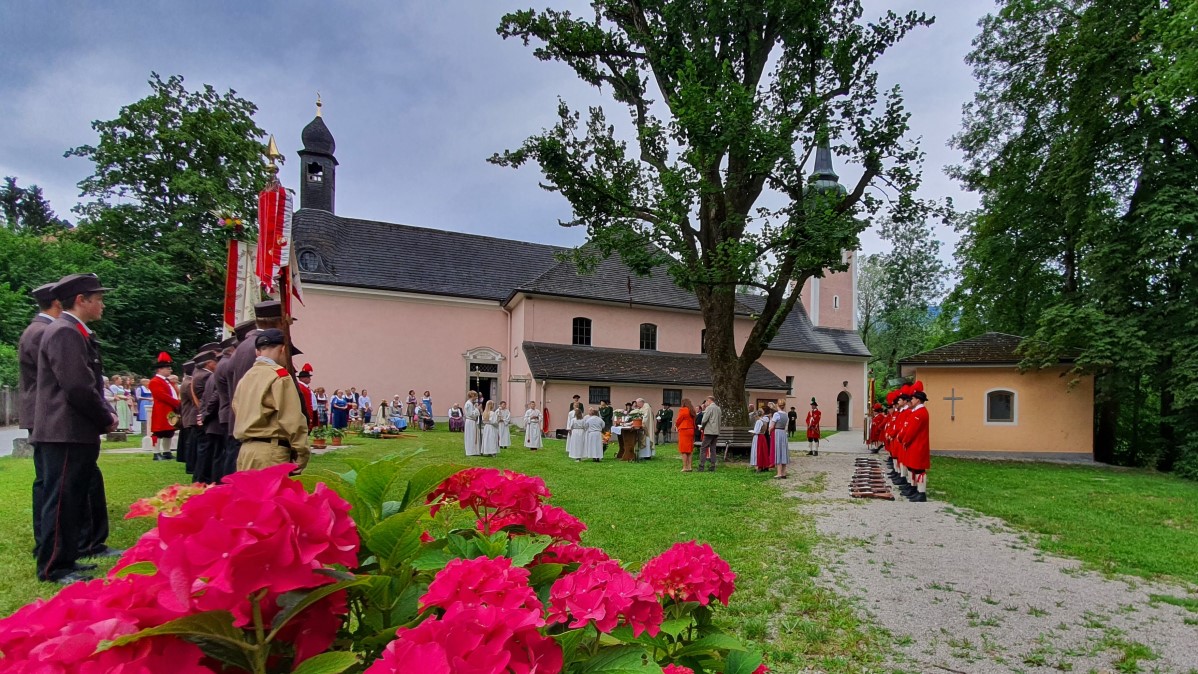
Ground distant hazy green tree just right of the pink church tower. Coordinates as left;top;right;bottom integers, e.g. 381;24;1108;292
858;220;948;382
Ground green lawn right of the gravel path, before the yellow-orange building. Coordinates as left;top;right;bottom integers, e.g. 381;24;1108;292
928;457;1198;584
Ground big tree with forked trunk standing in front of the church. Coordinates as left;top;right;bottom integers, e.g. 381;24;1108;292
491;0;932;423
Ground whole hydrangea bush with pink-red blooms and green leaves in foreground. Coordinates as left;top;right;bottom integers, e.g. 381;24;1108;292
0;462;768;674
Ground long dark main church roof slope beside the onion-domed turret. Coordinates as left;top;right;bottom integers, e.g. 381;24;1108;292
292;208;564;302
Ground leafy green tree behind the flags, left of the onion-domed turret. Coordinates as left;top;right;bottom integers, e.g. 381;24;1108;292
67;74;267;369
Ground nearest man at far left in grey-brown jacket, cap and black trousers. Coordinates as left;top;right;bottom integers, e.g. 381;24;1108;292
30;274;119;584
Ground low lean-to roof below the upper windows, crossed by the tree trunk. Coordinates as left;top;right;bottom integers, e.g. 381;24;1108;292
521;341;786;390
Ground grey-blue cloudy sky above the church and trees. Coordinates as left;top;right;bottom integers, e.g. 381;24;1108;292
0;0;993;256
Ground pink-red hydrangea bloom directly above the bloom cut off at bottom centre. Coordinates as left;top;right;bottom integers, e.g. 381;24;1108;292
420;557;544;627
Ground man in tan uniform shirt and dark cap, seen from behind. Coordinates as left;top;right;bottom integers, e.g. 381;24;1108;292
232;328;309;474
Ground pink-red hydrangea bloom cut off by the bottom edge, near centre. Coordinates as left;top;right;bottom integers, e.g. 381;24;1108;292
365;607;562;674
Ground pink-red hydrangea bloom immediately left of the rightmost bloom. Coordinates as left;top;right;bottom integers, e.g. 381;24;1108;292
549;559;662;637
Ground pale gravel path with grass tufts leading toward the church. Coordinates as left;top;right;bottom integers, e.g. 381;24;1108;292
787;442;1198;674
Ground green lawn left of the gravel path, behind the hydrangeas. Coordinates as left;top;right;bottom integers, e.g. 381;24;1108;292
0;430;887;673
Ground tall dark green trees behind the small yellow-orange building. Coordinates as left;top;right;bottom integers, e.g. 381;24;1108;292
949;0;1198;476
